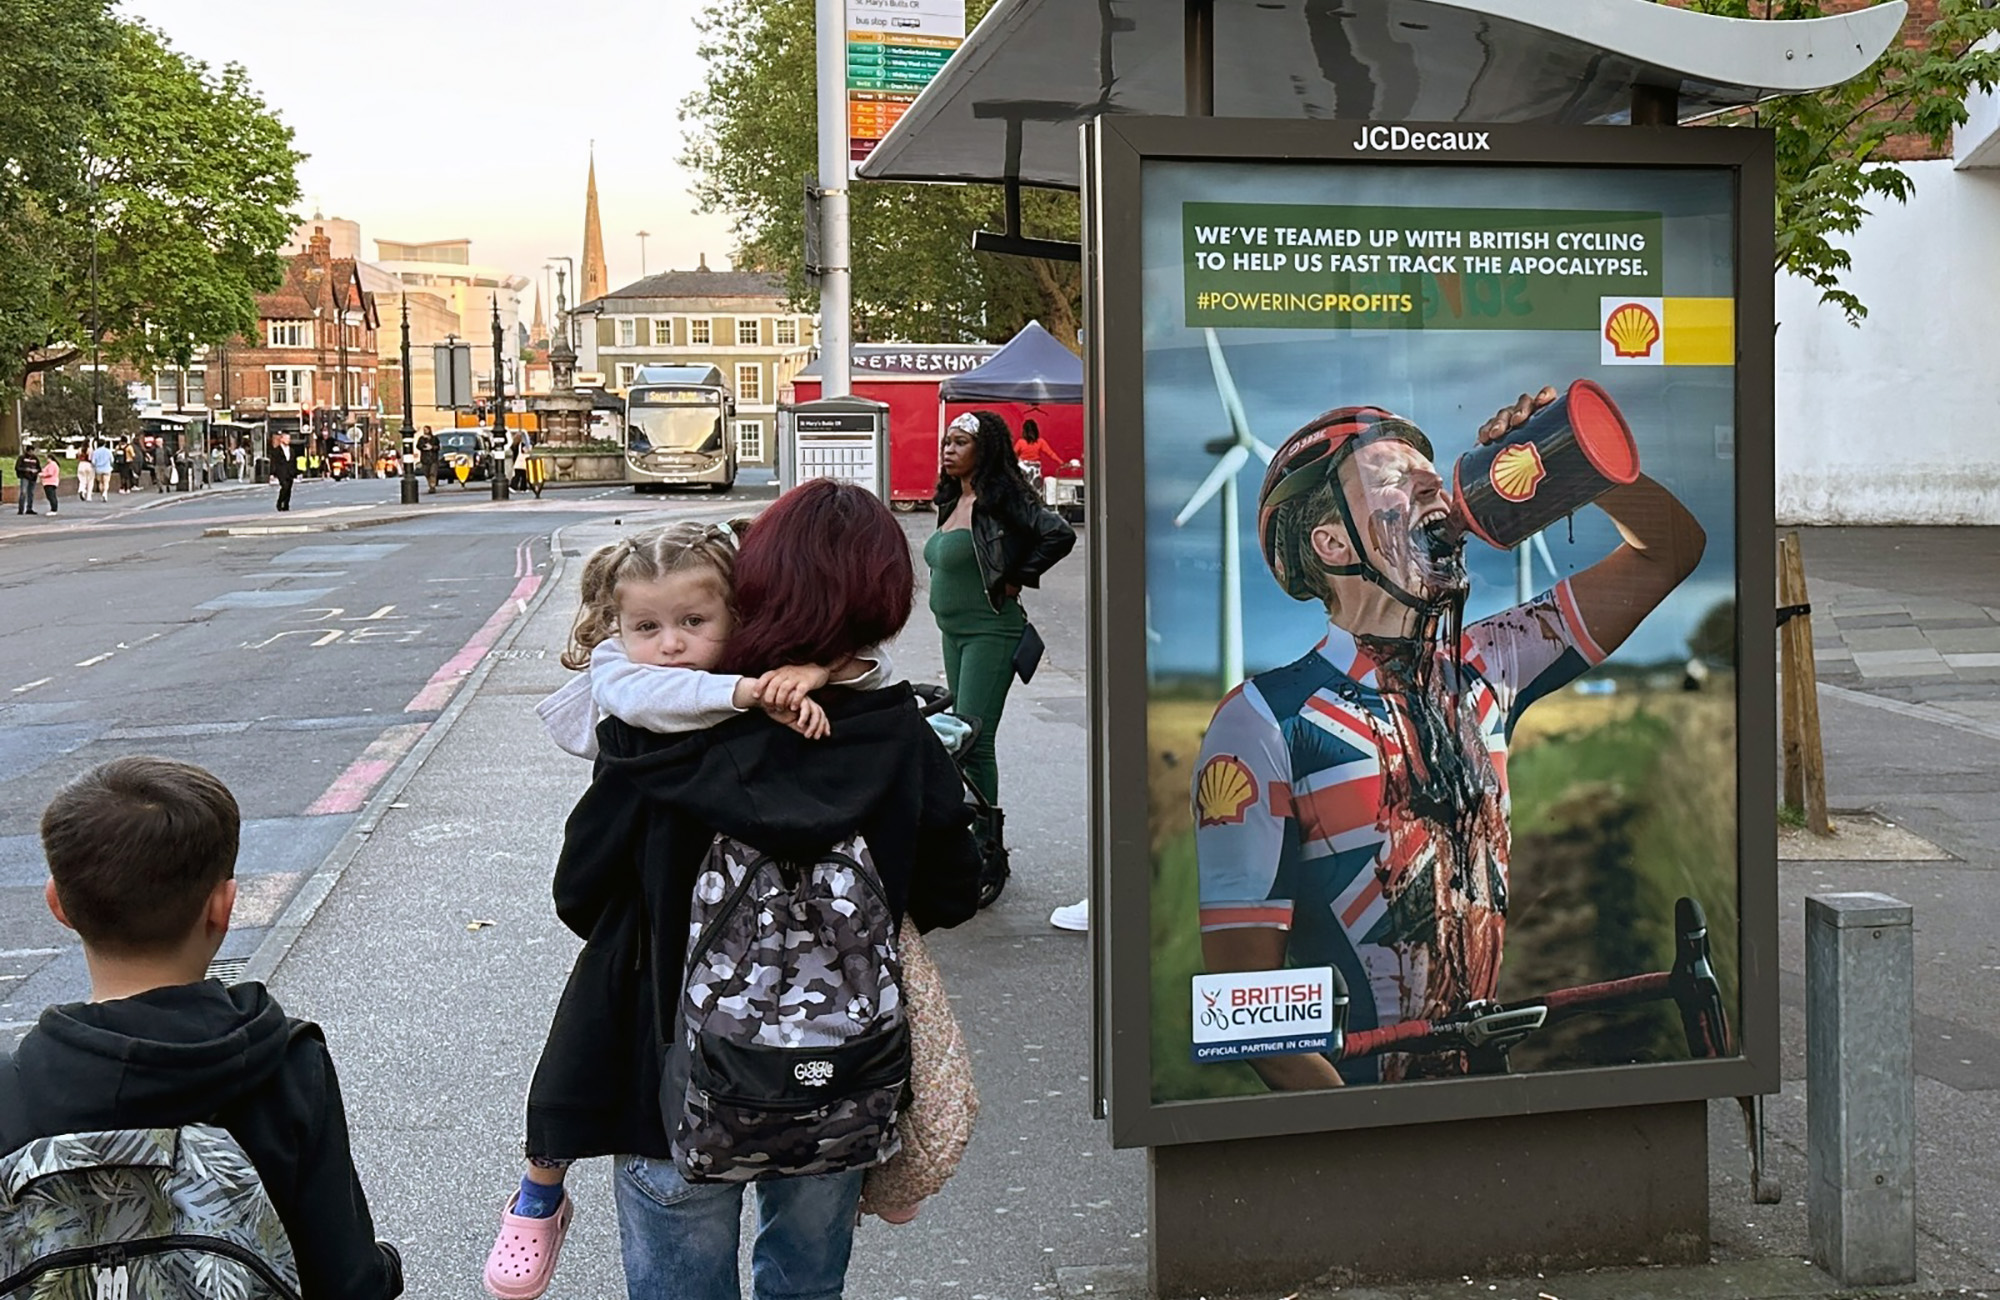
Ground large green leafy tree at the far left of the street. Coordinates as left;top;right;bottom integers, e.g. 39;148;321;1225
0;15;302;448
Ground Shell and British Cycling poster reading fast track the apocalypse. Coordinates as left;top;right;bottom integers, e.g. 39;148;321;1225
1138;158;1768;1104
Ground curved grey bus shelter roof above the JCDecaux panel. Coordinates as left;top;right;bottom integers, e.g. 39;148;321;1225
860;0;1906;188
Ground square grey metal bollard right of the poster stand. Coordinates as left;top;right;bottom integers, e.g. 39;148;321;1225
1806;894;1916;1286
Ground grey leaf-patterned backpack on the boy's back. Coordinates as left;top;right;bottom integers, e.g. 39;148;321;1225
0;1124;298;1300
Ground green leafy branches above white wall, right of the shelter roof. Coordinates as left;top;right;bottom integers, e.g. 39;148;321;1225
1686;0;2000;324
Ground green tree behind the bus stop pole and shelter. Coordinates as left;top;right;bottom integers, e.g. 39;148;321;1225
682;0;1082;346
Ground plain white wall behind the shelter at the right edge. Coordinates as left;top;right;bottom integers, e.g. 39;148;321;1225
1776;160;2000;524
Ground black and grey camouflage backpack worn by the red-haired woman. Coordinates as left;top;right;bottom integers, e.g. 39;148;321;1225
662;836;910;1182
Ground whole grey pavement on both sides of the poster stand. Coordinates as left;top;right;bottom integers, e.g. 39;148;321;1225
250;510;2000;1300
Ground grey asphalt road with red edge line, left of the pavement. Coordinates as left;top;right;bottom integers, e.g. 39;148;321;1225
0;466;772;1050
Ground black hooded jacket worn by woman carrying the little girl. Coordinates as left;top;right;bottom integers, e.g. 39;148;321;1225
528;682;978;1160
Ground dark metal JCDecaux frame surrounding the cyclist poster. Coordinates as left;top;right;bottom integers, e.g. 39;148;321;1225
1080;116;1780;1148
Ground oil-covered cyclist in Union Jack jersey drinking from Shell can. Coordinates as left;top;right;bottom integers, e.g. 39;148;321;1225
1192;384;1706;1090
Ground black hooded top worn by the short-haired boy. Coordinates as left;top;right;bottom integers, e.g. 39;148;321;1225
0;980;402;1300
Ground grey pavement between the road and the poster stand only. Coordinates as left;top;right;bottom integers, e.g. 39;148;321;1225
266;508;1146;1300
